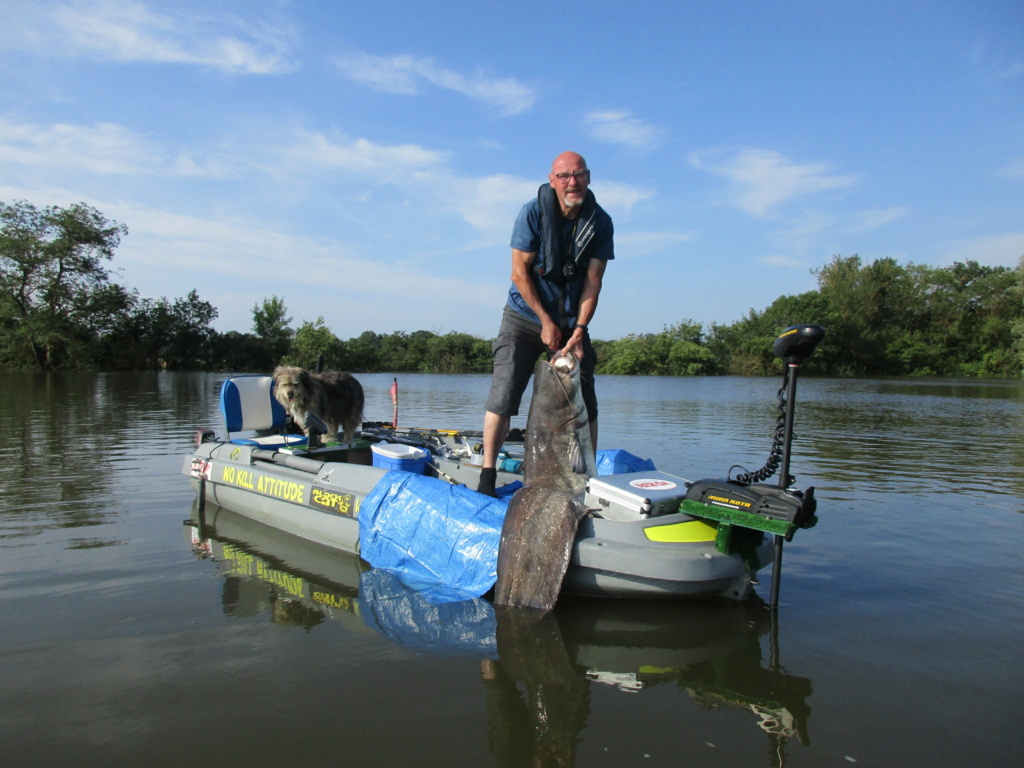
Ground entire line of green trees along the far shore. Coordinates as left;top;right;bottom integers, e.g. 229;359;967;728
6;201;1024;377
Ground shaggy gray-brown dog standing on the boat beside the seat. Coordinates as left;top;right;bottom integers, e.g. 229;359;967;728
273;366;362;443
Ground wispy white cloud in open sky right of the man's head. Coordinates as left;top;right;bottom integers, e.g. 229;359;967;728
689;150;857;218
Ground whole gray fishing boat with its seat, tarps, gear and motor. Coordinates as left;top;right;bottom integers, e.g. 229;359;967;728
182;326;824;607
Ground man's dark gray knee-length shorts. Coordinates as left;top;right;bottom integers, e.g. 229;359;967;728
485;306;597;421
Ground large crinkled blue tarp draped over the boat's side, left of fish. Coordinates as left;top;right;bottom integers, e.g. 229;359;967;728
359;470;508;602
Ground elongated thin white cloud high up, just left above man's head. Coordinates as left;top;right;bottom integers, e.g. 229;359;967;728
336;53;537;116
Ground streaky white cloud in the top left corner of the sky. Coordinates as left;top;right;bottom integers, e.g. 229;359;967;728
0;0;291;75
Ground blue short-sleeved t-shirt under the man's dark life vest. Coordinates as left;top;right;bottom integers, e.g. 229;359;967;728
508;198;615;325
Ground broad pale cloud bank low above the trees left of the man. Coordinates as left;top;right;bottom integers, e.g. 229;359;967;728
97;202;501;333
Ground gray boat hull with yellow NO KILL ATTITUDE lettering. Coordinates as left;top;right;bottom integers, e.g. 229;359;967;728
188;441;772;600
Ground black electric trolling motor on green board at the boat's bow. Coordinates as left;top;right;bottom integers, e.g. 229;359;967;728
680;325;825;609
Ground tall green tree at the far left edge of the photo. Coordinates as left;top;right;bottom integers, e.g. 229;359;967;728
0;201;130;369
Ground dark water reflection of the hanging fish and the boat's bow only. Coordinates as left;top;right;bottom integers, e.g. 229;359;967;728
484;599;811;766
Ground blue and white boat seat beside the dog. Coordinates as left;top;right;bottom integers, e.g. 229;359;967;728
220;374;306;450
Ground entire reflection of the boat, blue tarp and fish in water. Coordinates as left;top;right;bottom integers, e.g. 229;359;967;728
190;503;811;766
